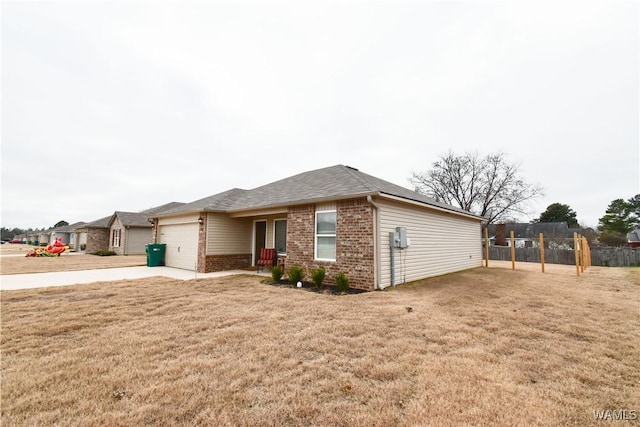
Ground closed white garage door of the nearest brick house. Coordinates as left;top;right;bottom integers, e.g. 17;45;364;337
158;223;198;270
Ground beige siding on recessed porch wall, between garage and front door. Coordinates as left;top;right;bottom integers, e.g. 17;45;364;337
207;213;252;255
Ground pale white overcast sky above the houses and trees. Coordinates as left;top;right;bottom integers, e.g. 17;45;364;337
0;1;640;228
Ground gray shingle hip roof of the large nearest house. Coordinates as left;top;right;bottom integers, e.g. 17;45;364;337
159;165;482;216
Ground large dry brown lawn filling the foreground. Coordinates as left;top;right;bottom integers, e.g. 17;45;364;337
0;266;640;426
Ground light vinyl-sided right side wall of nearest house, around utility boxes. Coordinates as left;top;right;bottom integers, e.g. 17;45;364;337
377;200;482;288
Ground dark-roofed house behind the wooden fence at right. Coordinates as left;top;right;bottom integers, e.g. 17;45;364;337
489;222;582;249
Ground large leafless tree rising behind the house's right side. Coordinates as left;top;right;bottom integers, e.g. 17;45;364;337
409;151;542;223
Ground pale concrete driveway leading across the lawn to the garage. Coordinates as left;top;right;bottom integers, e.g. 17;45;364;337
0;266;269;290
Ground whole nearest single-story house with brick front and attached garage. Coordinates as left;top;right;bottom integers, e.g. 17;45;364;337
150;165;484;290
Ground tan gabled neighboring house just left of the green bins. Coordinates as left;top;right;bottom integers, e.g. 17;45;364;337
107;202;184;255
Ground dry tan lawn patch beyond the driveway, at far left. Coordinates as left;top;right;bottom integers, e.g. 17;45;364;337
0;244;147;274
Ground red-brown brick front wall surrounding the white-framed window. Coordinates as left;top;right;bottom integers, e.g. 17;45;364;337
285;198;375;290
